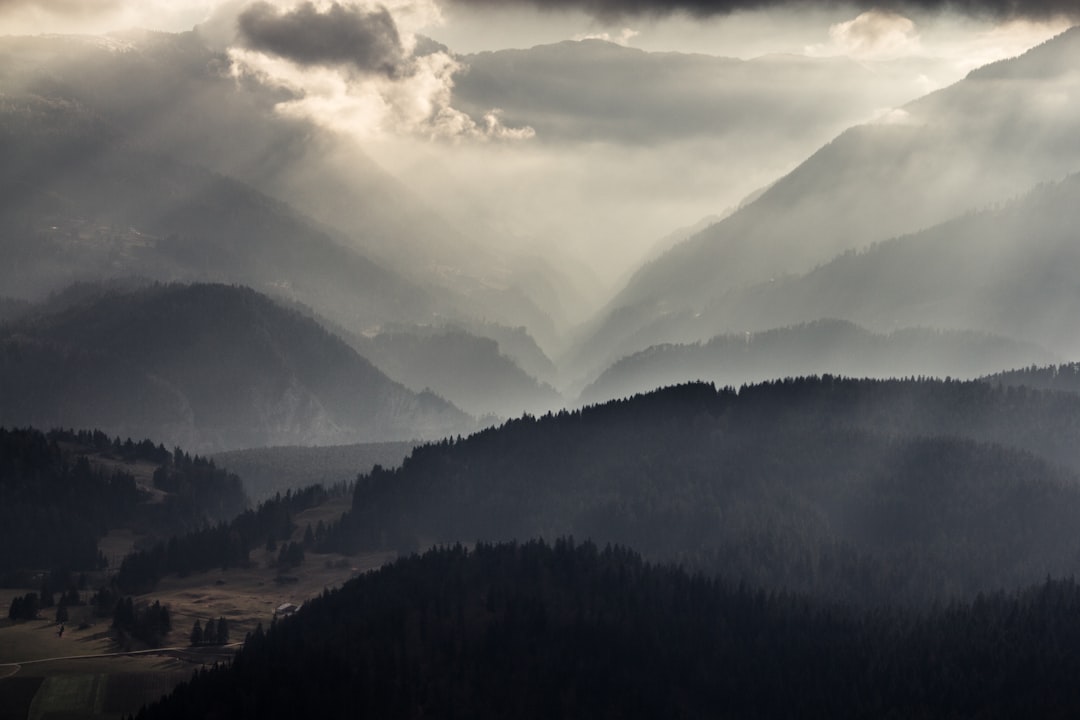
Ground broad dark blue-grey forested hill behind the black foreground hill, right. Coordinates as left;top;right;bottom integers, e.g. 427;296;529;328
327;377;1080;602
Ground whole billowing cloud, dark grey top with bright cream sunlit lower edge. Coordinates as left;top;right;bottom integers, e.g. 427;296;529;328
229;2;534;139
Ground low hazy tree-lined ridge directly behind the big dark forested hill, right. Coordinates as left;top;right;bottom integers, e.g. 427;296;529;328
579;321;1053;403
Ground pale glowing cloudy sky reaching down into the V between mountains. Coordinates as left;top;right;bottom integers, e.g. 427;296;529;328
0;0;1076;302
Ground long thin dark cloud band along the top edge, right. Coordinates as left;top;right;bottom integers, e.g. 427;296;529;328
440;0;1080;19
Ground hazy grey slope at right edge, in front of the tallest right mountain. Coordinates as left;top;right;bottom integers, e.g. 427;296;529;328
669;169;1080;360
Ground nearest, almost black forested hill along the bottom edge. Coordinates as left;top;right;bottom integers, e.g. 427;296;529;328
138;541;1080;720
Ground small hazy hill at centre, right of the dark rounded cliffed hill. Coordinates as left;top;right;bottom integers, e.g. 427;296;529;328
355;327;563;418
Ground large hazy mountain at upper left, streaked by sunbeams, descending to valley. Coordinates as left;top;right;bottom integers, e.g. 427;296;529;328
0;31;566;347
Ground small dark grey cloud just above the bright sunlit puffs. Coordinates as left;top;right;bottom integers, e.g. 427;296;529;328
237;2;405;77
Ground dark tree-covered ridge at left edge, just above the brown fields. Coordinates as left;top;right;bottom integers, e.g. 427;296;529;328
0;427;247;573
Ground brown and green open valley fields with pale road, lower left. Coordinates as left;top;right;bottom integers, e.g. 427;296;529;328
0;501;394;720
